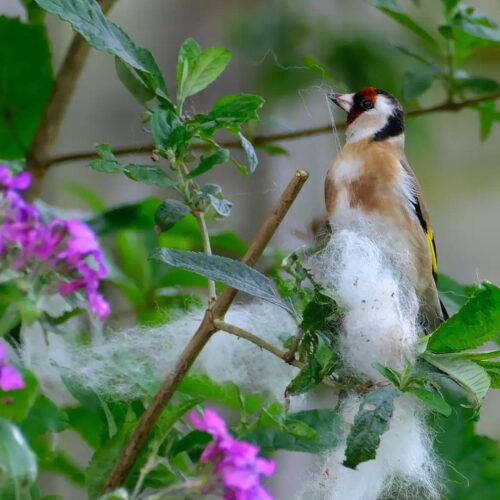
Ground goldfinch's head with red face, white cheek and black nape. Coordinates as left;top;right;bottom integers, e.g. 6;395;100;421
329;87;404;142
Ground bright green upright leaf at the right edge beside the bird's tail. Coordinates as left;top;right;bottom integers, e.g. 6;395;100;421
427;283;500;353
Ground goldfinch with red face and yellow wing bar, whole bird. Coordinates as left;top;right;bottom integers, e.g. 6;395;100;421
325;87;448;332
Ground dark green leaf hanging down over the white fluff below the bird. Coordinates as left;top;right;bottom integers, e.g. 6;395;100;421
344;387;399;469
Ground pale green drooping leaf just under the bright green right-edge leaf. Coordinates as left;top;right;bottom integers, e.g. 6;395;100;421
423;354;490;407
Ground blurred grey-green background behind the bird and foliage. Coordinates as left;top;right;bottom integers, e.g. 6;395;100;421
0;0;500;499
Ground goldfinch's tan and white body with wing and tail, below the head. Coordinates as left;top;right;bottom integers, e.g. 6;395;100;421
325;89;444;329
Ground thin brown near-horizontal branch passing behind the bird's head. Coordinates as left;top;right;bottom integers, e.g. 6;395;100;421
47;92;500;167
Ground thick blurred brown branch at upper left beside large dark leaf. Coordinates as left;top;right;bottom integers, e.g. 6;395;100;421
26;0;116;194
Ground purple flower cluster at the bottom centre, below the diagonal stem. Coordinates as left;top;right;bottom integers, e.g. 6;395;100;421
190;409;276;500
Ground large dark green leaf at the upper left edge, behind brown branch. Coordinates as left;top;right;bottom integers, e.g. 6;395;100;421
0;17;54;159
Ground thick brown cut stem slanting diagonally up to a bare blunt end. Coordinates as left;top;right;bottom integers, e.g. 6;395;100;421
105;170;309;492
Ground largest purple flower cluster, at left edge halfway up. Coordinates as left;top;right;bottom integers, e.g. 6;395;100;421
0;165;110;320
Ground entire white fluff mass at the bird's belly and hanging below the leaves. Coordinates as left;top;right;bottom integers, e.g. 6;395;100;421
298;230;439;500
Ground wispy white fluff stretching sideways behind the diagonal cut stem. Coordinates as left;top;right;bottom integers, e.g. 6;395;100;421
23;302;297;403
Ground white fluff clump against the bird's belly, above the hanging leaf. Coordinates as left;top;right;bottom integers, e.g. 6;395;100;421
308;230;419;381
